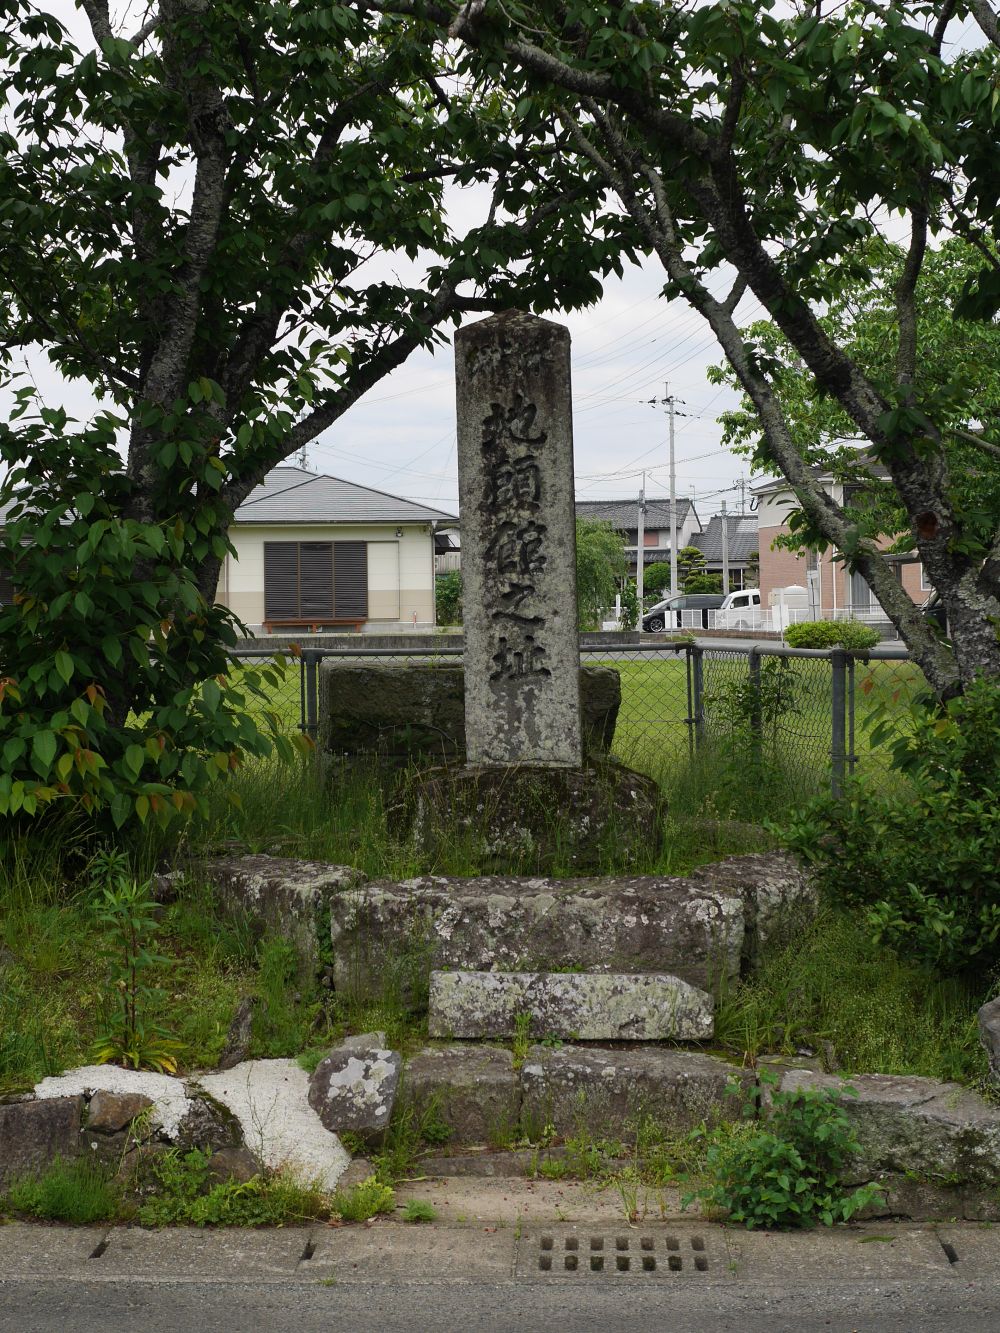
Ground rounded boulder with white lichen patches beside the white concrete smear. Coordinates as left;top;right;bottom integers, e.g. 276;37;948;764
309;1040;403;1148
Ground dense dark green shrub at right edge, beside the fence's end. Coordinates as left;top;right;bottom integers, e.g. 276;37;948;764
783;680;1000;977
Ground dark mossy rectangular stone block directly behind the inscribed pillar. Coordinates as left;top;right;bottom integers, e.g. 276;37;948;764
319;660;621;766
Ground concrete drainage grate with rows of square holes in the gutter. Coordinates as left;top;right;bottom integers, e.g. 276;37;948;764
517;1229;709;1278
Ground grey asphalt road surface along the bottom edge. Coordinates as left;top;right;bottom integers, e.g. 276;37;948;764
0;1278;1000;1333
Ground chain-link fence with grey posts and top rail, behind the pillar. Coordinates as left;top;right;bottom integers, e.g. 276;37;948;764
226;641;925;792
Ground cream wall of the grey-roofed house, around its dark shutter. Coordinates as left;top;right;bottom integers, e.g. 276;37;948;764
216;523;435;627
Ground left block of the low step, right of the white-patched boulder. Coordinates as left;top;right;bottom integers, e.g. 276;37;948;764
399;1041;521;1144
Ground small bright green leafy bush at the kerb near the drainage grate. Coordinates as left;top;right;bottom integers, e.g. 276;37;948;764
684;1073;879;1229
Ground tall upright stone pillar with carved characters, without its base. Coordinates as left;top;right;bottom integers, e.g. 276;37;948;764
455;311;583;768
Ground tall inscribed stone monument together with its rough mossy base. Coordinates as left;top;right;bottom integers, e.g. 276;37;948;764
405;311;660;873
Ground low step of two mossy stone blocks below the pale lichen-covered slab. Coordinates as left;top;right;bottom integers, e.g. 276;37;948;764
397;1041;753;1152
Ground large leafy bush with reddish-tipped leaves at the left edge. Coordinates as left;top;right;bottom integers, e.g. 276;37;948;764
0;415;308;832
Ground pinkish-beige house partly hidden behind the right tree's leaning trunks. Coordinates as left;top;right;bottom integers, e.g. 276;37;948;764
753;476;932;620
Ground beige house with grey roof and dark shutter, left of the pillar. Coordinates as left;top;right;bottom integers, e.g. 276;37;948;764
216;467;456;632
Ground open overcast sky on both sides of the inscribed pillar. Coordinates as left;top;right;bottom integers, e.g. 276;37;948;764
297;268;768;517
